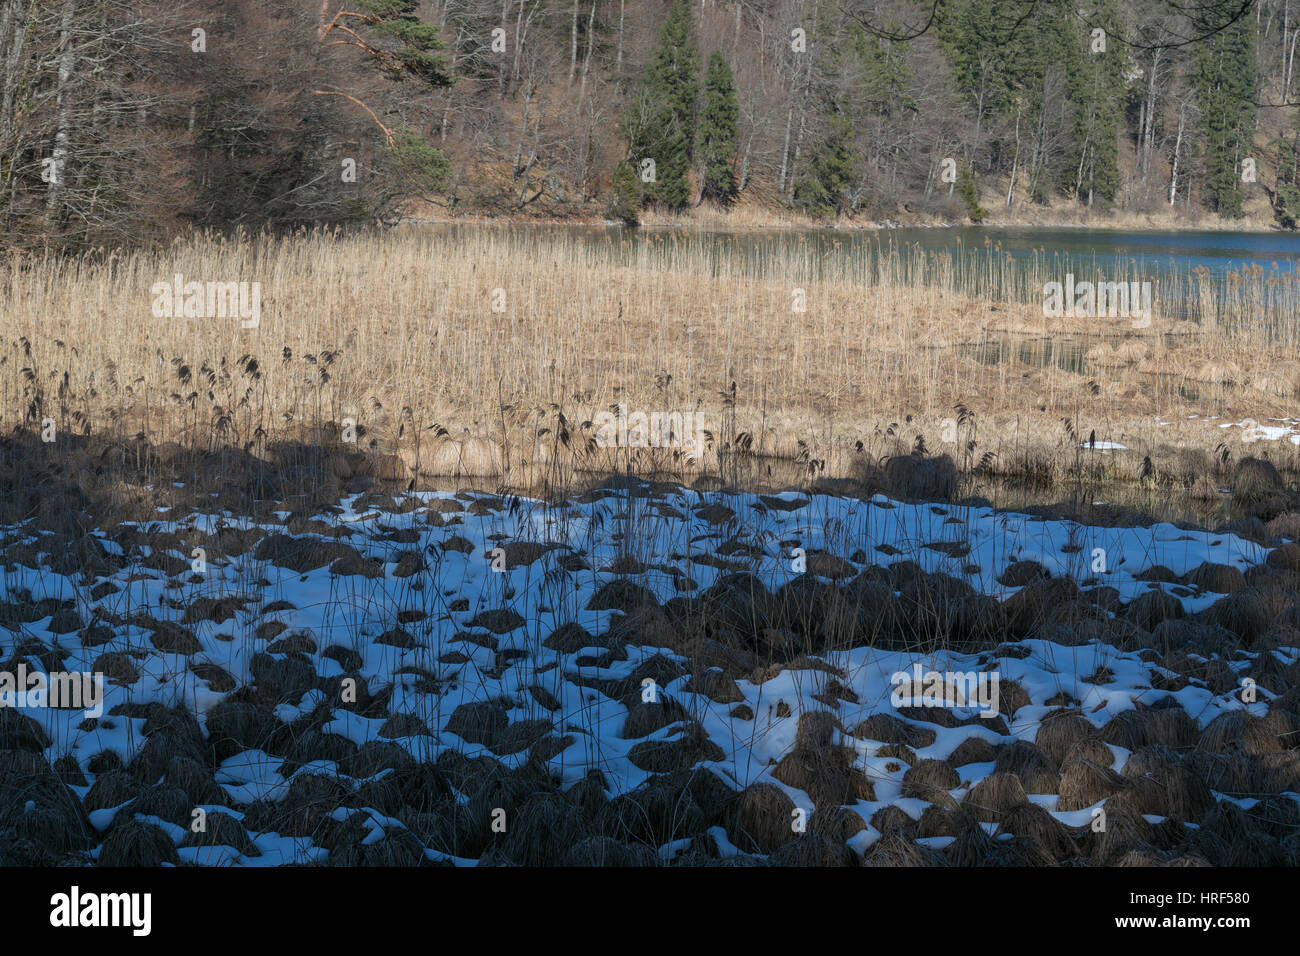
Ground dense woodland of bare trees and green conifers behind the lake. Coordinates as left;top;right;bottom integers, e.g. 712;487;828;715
0;0;1300;246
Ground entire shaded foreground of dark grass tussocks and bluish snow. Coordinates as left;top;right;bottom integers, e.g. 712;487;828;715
0;442;1300;866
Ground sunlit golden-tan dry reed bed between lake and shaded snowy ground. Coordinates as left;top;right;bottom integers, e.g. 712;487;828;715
0;228;1300;485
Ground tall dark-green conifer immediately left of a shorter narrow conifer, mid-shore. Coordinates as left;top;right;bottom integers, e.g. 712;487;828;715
624;0;699;209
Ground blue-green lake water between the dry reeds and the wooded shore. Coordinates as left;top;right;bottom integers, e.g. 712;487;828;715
454;226;1300;317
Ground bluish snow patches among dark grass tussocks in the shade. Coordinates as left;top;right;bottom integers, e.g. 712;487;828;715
0;485;1300;865
